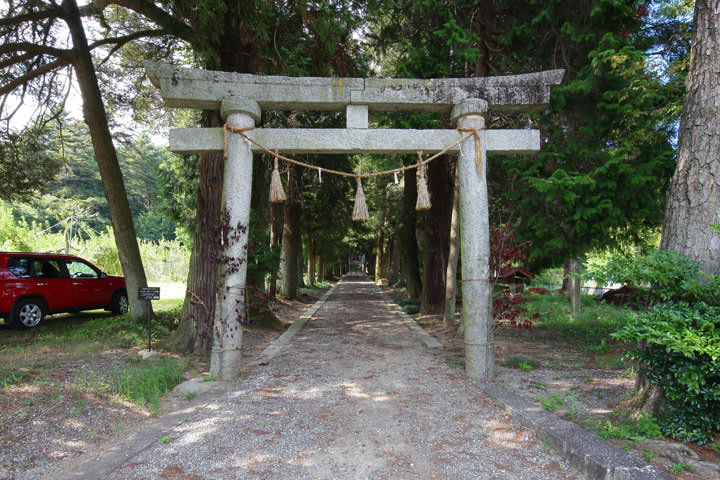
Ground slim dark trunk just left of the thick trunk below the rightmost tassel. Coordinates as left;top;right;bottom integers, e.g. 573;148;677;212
400;169;422;298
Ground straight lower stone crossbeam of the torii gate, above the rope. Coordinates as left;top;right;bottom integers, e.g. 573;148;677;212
170;128;540;154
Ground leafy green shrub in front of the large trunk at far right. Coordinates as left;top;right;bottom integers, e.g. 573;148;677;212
590;251;720;444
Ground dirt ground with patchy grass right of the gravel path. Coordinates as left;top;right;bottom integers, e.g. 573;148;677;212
417;315;720;480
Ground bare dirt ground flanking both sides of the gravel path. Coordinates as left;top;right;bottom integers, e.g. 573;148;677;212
0;284;720;480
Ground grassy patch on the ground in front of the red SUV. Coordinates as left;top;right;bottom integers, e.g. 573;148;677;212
0;299;187;413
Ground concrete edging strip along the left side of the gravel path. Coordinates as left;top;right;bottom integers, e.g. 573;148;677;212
46;282;340;480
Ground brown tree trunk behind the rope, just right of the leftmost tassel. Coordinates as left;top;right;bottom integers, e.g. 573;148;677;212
280;165;300;298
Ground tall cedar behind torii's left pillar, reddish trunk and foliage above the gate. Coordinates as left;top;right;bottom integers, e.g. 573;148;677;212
96;0;366;352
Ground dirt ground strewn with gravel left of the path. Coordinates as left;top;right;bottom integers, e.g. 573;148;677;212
0;291;323;480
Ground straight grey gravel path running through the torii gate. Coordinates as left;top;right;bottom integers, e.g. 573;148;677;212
107;276;582;480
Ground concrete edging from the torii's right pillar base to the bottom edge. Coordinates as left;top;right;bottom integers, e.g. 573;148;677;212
481;382;671;480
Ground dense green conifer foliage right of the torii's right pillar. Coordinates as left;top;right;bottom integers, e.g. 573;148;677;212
493;0;683;268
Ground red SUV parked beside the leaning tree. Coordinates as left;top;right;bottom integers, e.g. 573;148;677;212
0;252;128;328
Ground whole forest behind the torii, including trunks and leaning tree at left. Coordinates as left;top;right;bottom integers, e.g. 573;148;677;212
0;0;720;446
